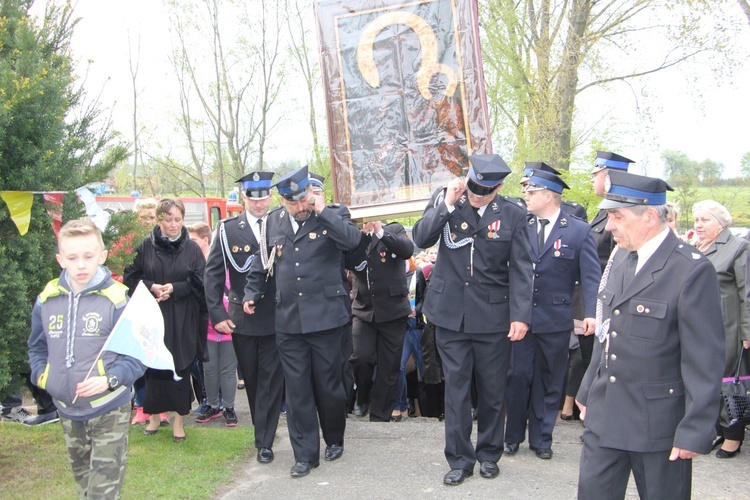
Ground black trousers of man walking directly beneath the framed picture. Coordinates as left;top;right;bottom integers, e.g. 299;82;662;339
349;316;406;422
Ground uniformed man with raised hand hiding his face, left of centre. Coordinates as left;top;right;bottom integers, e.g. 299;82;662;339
244;166;361;477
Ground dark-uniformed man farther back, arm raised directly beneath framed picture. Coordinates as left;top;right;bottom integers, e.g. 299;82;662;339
348;221;414;422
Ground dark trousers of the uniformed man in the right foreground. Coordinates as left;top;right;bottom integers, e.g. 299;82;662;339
578;429;693;500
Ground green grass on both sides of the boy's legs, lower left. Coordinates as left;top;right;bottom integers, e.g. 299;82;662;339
0;423;255;500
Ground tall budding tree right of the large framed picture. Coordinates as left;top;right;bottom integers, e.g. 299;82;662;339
480;0;730;169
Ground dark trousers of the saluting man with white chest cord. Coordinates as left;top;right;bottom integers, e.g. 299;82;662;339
435;327;511;470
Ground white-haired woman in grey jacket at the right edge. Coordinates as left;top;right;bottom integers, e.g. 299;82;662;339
693;200;750;458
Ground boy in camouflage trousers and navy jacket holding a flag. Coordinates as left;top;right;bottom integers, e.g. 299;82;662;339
28;220;145;498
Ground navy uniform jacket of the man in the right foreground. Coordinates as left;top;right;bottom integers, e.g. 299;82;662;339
576;231;724;453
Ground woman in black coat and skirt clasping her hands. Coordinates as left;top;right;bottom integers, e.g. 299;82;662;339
124;198;206;442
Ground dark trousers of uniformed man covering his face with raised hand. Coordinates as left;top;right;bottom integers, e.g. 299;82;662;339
276;325;346;462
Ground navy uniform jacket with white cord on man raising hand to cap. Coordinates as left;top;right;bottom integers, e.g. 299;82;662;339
412;188;532;333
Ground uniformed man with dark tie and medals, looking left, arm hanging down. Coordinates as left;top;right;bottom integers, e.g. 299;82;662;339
505;169;601;459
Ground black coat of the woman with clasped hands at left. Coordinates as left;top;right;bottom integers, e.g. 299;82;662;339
123;226;206;371
